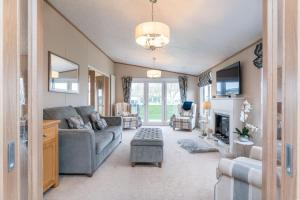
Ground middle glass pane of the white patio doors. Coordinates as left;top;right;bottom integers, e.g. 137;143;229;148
147;83;163;122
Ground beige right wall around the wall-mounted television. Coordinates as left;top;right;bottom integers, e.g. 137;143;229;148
211;40;262;145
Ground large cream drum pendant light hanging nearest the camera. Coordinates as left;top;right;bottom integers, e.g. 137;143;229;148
135;0;170;50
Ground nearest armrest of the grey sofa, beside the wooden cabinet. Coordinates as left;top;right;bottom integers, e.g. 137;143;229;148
59;129;96;175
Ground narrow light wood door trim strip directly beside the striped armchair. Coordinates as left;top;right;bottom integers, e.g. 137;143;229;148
262;0;277;200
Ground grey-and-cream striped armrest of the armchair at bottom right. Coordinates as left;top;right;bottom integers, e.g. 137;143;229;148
217;158;262;188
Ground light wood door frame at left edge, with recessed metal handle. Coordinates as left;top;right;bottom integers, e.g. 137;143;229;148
0;0;44;200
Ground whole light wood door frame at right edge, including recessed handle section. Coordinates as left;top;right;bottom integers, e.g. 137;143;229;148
262;0;300;200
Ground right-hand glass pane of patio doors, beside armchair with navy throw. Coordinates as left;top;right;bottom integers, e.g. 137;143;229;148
166;83;181;121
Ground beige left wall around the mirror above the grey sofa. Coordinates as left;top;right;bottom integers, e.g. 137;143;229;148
43;2;114;107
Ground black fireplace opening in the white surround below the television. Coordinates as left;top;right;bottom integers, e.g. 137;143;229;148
215;113;230;144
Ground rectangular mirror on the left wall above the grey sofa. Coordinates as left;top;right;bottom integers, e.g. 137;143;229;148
48;52;79;93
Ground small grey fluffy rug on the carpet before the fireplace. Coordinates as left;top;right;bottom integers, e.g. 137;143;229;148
177;138;218;153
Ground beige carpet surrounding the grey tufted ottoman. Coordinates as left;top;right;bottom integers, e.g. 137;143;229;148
44;127;219;200
